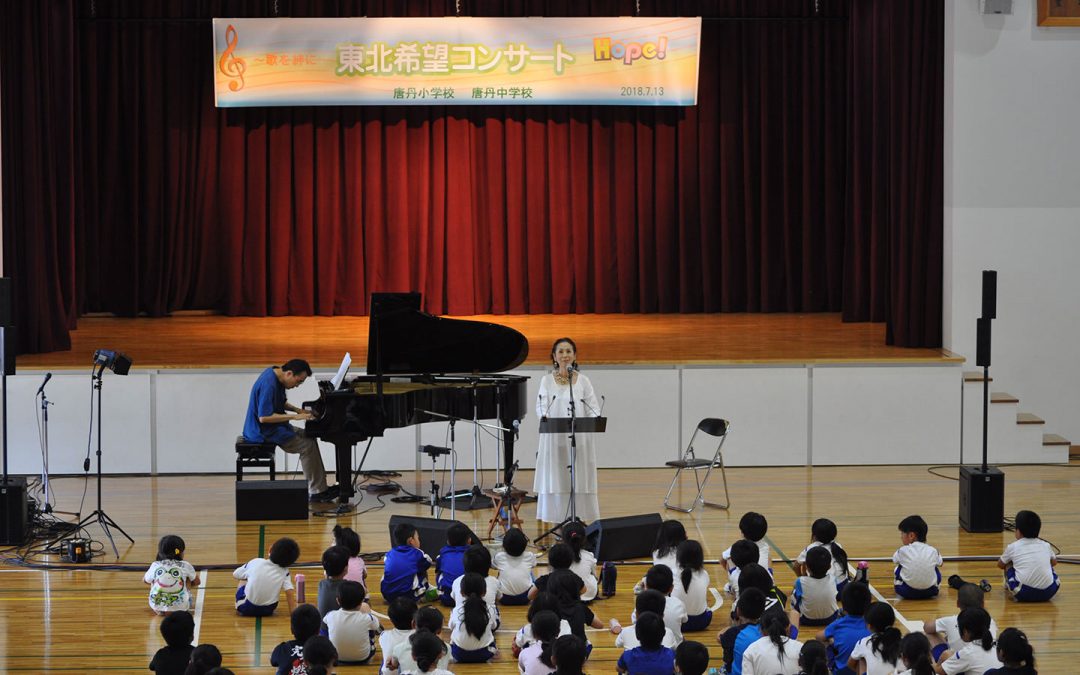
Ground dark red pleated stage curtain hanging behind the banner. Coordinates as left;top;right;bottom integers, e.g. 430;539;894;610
2;0;942;351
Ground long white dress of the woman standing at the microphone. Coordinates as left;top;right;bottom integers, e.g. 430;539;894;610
532;373;600;523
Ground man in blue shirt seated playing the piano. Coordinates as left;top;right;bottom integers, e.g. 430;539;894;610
244;359;337;502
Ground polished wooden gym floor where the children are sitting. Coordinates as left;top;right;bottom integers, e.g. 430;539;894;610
0;465;1080;675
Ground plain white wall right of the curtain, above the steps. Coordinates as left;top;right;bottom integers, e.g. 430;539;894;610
944;0;1080;443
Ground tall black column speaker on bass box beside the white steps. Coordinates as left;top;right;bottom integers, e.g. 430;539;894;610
960;270;1005;532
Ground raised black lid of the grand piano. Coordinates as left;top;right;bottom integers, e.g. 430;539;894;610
367;293;529;375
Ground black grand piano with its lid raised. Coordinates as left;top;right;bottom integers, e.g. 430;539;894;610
303;293;529;504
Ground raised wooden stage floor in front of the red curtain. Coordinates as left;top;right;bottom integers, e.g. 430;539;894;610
17;314;962;369
